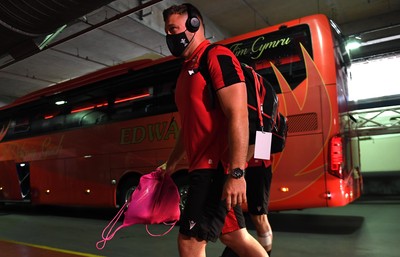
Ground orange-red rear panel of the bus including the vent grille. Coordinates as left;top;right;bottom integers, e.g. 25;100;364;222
270;82;327;210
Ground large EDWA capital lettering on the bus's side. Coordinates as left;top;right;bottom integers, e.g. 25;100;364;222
120;120;179;145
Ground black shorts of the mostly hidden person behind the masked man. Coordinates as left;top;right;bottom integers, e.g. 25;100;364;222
246;163;272;215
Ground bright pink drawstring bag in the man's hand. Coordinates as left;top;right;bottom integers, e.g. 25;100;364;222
96;169;180;250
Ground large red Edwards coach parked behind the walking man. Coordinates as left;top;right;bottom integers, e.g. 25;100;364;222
0;15;362;211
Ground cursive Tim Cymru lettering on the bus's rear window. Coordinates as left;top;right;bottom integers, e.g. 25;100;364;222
230;36;291;60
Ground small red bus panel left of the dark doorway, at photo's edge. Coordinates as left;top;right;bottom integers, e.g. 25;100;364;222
0;161;22;201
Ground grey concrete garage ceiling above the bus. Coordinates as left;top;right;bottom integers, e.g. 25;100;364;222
0;0;400;106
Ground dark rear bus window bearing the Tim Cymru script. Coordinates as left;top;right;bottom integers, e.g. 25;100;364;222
228;25;312;93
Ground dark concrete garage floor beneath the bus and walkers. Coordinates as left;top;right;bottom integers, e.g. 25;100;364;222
0;200;400;257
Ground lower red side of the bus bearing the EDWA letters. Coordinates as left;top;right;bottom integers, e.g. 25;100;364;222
0;113;180;207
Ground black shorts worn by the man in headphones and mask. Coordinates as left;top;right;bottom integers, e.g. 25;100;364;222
179;165;246;242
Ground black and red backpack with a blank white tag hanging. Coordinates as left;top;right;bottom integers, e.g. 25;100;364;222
199;44;287;153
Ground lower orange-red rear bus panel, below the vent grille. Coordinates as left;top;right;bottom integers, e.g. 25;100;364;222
269;134;326;210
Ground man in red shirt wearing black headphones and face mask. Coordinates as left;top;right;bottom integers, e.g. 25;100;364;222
163;4;267;257
